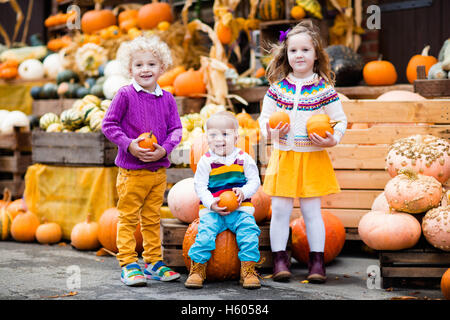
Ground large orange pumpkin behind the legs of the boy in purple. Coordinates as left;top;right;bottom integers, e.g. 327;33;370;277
98;207;144;253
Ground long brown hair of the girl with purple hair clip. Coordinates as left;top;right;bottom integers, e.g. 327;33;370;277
266;20;335;85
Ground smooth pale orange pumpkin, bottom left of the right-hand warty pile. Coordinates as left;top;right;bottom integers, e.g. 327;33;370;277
358;211;422;250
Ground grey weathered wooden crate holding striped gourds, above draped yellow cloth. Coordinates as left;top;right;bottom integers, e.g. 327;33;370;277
32;130;117;166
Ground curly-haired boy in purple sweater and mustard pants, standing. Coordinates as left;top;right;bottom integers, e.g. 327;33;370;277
102;37;182;286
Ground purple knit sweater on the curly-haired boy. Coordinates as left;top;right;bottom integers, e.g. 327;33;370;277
102;85;182;171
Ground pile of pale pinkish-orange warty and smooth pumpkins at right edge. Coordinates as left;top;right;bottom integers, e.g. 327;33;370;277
358;135;450;251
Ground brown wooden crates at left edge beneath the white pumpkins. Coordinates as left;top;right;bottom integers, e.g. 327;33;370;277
0;128;31;199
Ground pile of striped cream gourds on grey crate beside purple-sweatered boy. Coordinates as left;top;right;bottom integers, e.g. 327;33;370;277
39;95;111;133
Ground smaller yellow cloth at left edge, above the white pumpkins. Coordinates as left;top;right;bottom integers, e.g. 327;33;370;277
0;81;48;114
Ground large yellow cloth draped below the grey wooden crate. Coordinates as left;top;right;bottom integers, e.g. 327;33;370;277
24;164;118;240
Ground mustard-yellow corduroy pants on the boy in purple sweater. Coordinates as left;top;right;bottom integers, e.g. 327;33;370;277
117;168;167;267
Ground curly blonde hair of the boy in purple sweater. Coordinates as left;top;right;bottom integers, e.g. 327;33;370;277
116;36;172;76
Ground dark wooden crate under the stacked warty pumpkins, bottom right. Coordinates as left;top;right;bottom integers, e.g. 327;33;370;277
379;236;450;288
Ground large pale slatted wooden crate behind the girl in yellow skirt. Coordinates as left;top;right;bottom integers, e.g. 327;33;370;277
258;99;450;239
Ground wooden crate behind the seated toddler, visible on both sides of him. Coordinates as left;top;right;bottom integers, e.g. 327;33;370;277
161;219;284;268
